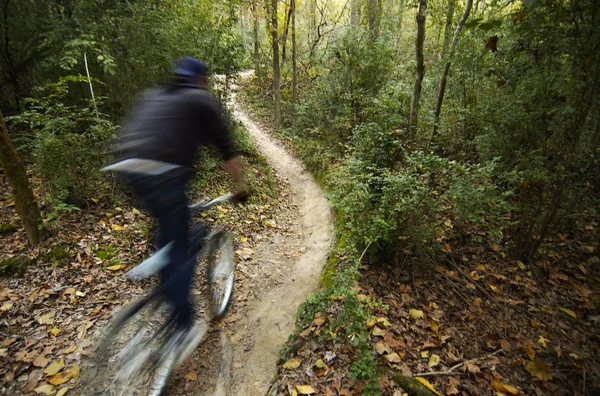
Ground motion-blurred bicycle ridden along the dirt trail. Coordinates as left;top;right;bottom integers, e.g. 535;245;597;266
86;194;234;396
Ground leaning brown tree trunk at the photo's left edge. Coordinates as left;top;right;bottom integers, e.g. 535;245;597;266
0;106;41;246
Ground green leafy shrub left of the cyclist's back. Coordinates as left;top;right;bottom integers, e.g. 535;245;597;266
9;76;115;204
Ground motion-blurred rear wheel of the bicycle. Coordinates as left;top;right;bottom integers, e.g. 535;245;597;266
82;291;175;396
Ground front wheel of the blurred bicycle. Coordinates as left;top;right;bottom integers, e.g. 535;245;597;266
206;231;235;320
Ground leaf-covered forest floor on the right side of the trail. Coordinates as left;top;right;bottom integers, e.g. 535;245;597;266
238;83;600;396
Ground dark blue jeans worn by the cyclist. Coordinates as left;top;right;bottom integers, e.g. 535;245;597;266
124;170;194;325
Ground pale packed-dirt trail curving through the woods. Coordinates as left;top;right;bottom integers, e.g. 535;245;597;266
226;90;333;395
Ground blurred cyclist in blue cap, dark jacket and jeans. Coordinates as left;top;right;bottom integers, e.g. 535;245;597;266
109;57;247;353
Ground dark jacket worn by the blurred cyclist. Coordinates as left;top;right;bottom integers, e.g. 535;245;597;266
117;83;237;167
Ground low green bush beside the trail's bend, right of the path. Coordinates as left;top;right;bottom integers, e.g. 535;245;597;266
331;152;511;253
